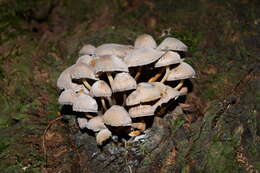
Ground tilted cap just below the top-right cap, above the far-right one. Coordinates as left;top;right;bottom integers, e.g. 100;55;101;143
154;51;181;67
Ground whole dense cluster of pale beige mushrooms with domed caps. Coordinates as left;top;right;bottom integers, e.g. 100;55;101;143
57;34;195;145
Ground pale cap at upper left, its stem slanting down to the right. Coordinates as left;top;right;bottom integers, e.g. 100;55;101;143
70;63;98;80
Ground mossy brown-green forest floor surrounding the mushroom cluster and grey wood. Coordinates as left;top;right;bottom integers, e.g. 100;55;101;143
0;0;260;173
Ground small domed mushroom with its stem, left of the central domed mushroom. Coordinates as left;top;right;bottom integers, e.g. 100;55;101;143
90;80;113;110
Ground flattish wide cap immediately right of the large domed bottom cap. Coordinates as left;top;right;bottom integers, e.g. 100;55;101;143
129;105;154;118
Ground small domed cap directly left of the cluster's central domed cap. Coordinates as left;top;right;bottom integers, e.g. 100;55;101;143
90;80;112;97
